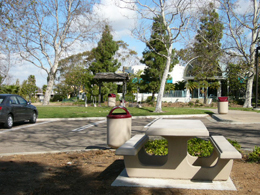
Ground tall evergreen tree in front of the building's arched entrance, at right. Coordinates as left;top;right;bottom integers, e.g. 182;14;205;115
188;3;224;103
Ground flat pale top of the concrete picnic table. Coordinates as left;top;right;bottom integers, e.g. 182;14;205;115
146;119;209;137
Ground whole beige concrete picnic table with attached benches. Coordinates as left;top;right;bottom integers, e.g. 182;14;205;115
116;119;241;181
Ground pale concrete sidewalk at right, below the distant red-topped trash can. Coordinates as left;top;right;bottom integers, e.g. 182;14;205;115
207;109;260;124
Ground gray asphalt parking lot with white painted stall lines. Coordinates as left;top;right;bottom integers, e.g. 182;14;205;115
0;117;260;155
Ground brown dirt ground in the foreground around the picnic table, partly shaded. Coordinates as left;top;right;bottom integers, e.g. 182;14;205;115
0;150;260;195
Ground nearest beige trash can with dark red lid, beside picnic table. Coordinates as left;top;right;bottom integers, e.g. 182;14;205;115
107;106;132;148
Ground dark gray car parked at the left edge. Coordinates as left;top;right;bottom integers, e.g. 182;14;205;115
0;94;38;128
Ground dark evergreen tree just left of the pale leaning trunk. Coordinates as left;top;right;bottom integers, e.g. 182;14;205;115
140;16;178;100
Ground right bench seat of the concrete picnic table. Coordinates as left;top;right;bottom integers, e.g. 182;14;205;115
210;136;242;159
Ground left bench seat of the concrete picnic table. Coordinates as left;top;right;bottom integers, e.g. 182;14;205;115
116;134;149;156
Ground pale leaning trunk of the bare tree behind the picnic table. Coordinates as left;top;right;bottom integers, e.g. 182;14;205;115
154;55;172;113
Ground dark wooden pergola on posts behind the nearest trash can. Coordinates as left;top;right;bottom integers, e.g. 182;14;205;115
94;72;129;106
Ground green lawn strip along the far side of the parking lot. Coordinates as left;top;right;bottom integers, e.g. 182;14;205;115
37;106;212;118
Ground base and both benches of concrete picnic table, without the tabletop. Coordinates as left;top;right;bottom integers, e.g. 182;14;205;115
116;134;241;181
